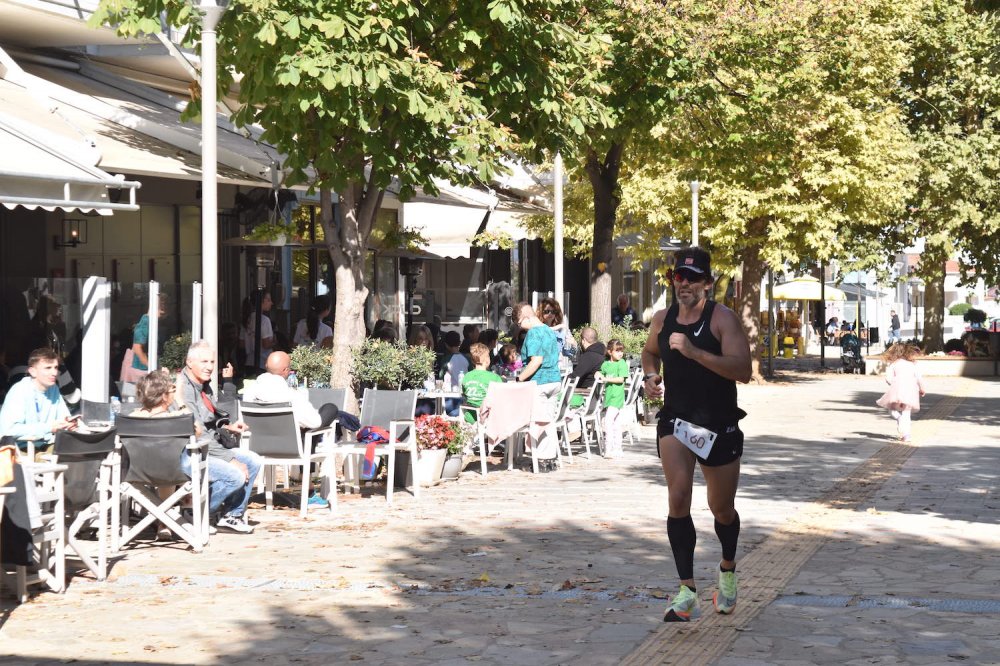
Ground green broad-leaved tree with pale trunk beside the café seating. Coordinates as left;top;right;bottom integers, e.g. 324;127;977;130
96;0;607;386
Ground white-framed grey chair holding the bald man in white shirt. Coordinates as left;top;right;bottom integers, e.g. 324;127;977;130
240;402;337;516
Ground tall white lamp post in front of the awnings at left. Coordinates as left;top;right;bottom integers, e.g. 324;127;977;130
197;0;228;389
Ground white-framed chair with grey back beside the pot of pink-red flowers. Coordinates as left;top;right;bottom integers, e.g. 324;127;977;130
337;389;420;504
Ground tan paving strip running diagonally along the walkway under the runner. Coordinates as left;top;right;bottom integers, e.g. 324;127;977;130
621;380;972;666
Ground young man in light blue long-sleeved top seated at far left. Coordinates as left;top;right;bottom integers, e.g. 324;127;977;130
0;347;77;455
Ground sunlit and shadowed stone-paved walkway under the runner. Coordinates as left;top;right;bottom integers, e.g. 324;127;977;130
0;373;1000;665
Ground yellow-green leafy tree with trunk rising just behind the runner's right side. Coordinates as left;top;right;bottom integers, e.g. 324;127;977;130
604;0;915;378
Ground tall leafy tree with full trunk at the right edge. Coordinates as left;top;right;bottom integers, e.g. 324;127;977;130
901;0;1000;351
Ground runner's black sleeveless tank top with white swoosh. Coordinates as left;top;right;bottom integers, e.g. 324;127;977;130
657;301;746;427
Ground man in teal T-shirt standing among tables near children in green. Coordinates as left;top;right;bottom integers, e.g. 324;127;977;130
513;302;562;471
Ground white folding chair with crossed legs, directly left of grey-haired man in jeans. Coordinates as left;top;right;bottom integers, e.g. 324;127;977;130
111;414;208;552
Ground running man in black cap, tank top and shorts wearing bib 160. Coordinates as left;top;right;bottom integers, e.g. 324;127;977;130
642;247;751;622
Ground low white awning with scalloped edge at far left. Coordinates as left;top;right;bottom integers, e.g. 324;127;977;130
0;113;139;215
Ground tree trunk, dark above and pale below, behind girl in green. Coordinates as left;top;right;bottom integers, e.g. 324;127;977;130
584;143;624;340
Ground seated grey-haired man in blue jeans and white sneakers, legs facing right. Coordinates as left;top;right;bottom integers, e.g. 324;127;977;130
177;340;261;534
